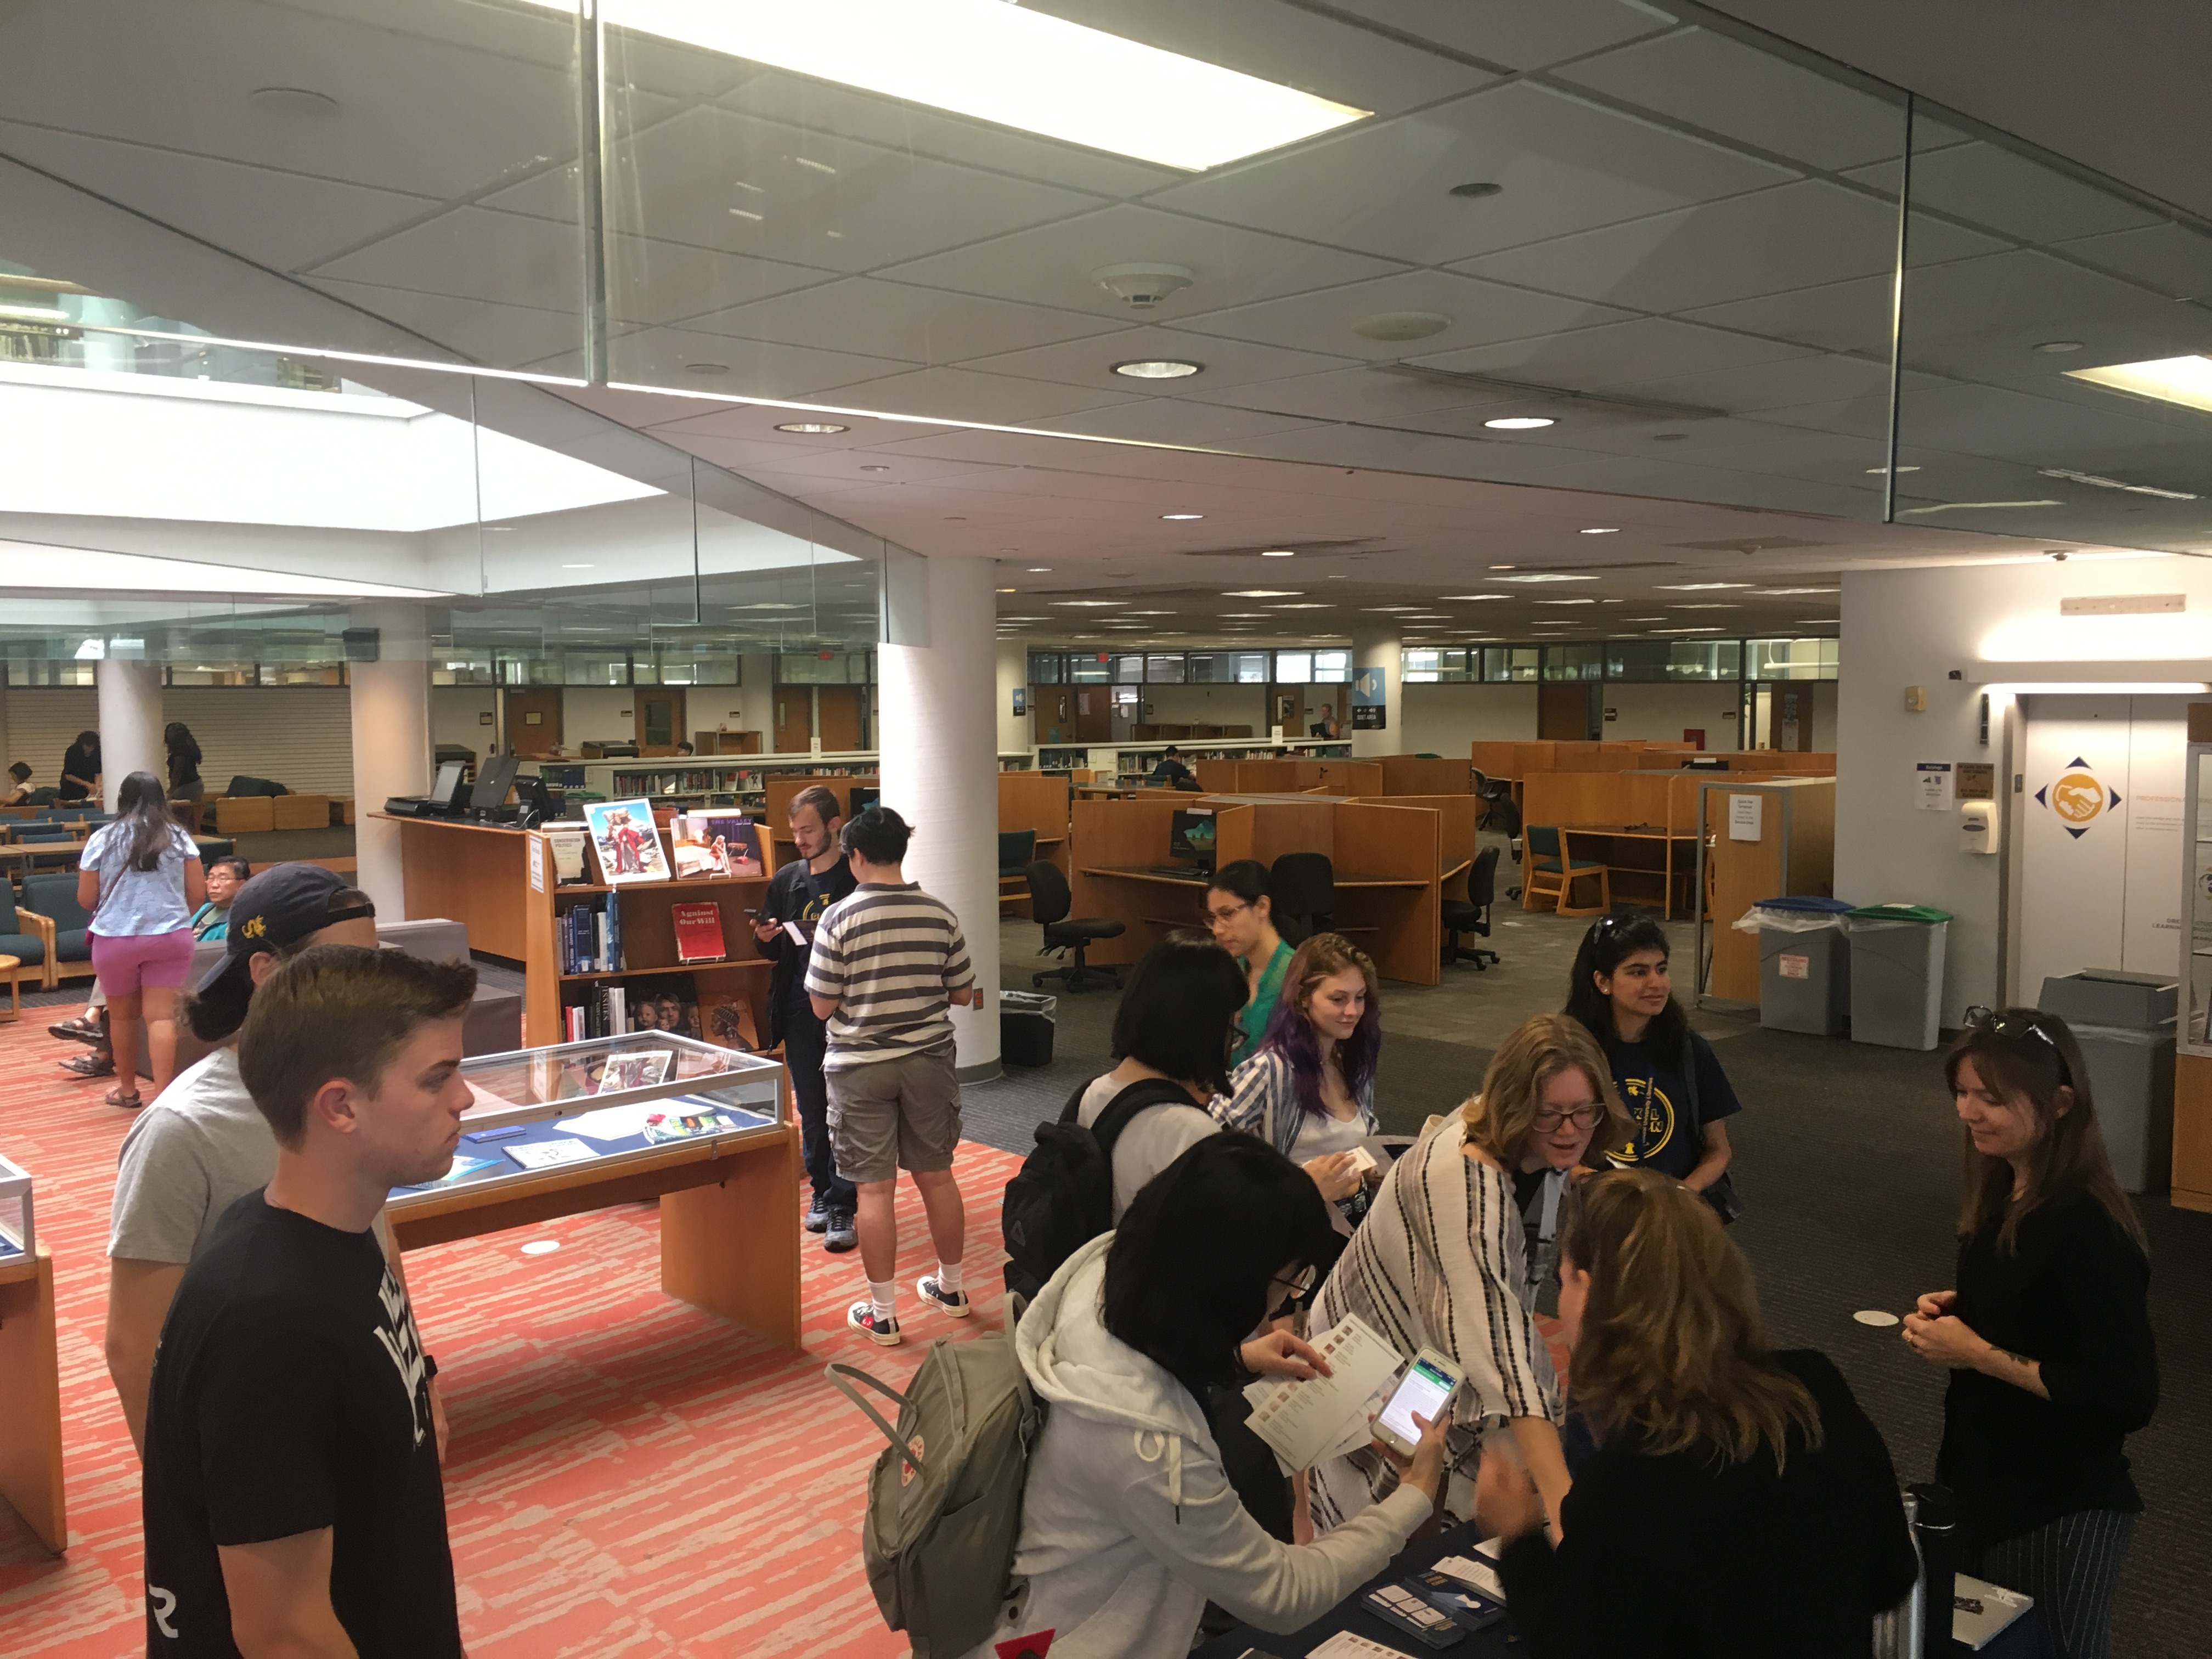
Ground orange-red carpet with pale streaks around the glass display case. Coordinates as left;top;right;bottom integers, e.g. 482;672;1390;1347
0;1026;1018;1659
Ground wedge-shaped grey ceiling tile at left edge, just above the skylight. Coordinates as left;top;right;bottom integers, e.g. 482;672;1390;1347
0;122;438;270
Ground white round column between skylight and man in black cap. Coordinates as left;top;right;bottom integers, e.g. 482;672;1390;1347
347;600;431;920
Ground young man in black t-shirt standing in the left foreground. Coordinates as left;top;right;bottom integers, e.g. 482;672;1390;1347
144;945;476;1659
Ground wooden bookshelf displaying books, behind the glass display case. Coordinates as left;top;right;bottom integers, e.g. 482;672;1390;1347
522;827;774;1048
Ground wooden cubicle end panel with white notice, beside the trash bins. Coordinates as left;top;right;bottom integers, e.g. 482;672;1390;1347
1699;778;1836;1002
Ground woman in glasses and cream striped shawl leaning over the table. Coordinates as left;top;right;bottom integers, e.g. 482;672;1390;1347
1307;1013;1628;1531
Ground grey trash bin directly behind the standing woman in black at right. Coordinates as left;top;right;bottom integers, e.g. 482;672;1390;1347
2035;969;2181;1192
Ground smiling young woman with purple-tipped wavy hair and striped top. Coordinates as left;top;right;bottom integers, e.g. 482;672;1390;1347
1212;934;1383;1223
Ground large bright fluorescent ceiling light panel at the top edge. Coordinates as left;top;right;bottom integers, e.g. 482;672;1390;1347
535;0;1369;172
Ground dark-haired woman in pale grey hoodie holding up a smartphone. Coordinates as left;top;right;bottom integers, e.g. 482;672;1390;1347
969;1135;1444;1659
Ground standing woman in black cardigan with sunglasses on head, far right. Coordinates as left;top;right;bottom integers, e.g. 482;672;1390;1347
1905;1009;2159;1659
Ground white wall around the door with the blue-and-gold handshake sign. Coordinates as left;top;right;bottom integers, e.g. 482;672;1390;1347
1814;555;2212;1026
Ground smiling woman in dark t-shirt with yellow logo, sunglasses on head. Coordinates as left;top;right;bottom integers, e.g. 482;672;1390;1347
1566;916;1741;1221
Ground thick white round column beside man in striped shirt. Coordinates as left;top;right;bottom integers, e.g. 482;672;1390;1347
876;553;997;1082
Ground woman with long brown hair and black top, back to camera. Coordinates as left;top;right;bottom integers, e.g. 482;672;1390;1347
1480;1170;1918;1659
